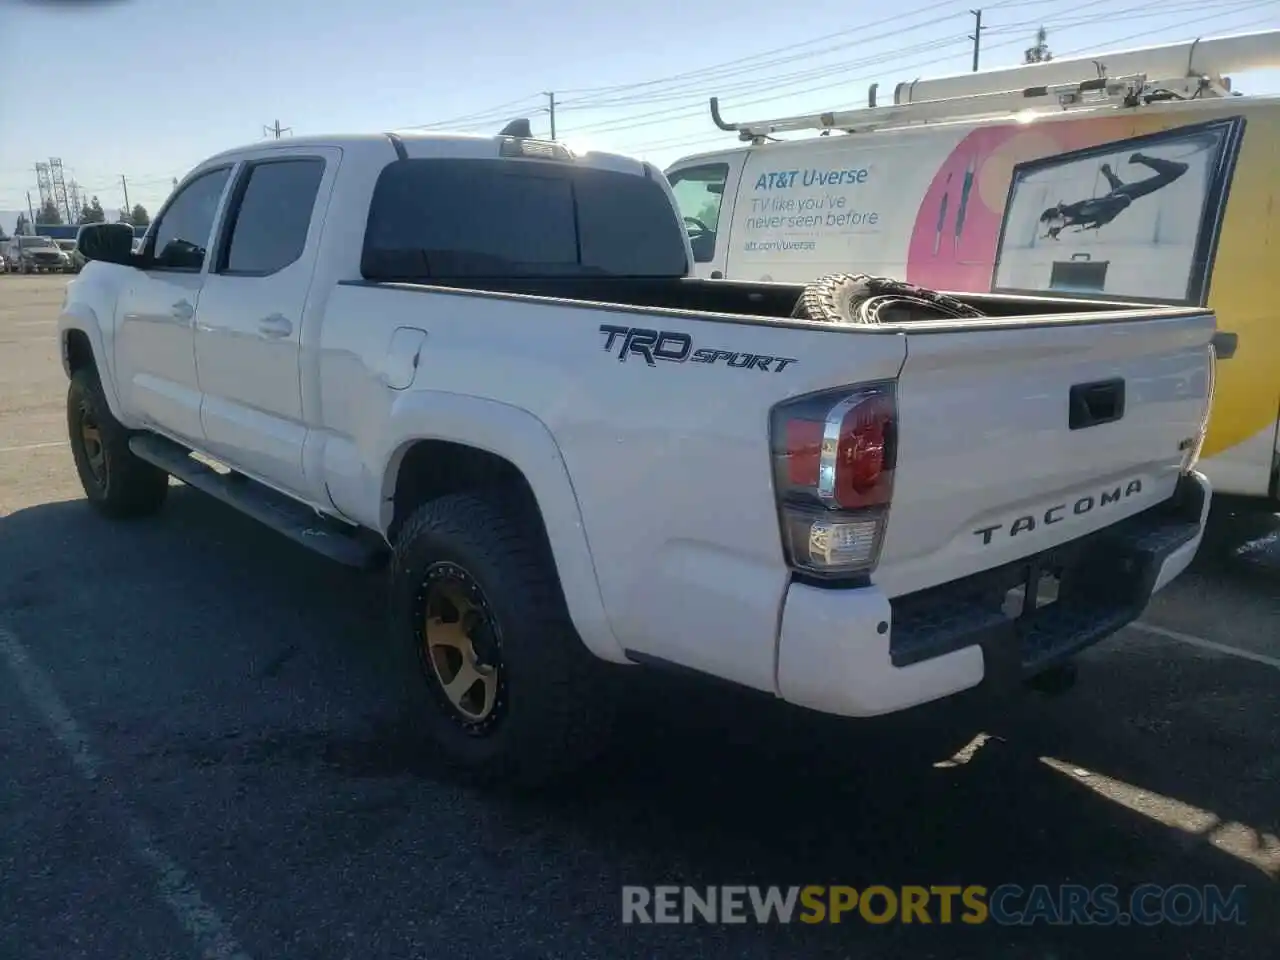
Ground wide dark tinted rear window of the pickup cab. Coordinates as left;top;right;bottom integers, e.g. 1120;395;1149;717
361;159;689;280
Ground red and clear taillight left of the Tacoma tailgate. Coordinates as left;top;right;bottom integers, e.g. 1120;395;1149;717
771;381;897;579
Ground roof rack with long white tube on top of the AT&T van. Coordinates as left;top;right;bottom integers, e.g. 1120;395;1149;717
710;29;1280;143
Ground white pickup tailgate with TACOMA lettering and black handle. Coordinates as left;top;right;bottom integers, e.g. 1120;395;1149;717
874;311;1216;596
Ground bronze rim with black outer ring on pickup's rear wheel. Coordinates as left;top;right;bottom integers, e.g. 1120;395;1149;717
413;562;507;736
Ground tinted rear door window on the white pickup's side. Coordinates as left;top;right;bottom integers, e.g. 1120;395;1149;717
223;157;324;274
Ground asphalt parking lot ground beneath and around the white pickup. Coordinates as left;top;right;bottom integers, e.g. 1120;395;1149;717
0;276;1280;960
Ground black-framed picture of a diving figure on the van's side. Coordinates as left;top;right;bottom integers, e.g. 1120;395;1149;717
991;116;1244;306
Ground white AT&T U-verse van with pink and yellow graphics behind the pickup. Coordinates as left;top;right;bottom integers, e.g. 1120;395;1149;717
667;31;1280;509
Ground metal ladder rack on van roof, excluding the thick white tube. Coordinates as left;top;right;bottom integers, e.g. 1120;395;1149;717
710;74;1230;143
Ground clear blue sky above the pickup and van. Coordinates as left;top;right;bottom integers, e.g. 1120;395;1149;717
0;0;1280;229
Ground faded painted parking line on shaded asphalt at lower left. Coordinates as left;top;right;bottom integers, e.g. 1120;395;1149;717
0;626;251;960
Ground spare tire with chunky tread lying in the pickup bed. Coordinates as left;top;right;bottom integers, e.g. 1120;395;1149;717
791;274;983;324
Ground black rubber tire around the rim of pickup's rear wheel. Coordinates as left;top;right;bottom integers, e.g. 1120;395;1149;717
389;493;614;787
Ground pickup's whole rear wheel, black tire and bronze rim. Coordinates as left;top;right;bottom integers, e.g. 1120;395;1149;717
390;494;613;785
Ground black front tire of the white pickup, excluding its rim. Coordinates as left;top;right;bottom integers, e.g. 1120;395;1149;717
67;369;169;520
